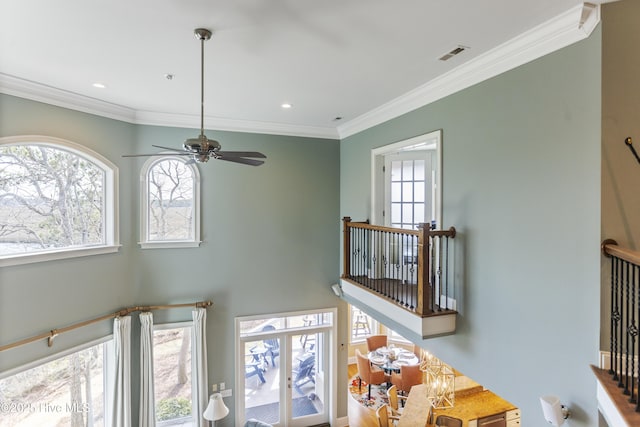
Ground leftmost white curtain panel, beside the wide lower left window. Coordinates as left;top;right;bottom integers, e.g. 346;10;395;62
111;316;131;427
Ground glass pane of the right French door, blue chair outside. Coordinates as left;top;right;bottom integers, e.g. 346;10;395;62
289;334;324;419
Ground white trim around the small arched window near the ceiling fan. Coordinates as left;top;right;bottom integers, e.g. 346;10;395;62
138;153;202;249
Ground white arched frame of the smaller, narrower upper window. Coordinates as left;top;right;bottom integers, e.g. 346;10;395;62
140;153;201;249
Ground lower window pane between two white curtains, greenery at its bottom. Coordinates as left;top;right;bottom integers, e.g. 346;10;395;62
153;328;192;421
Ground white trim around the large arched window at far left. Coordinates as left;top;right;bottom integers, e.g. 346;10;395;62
0;135;120;267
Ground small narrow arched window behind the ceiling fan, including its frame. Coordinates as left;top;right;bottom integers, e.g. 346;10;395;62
140;154;200;248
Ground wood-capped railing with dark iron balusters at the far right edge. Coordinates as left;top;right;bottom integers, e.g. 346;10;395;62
602;240;640;425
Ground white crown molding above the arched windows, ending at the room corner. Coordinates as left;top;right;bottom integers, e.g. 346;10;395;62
0;73;338;139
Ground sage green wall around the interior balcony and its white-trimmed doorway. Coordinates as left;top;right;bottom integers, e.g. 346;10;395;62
340;28;601;426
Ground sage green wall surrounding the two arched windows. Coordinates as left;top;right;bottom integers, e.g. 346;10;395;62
0;95;346;426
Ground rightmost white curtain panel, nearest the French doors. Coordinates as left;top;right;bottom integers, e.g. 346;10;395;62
191;308;209;427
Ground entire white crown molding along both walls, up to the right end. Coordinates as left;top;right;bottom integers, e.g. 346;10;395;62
0;3;600;139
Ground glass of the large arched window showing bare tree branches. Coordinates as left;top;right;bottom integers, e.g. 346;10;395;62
0;144;105;255
